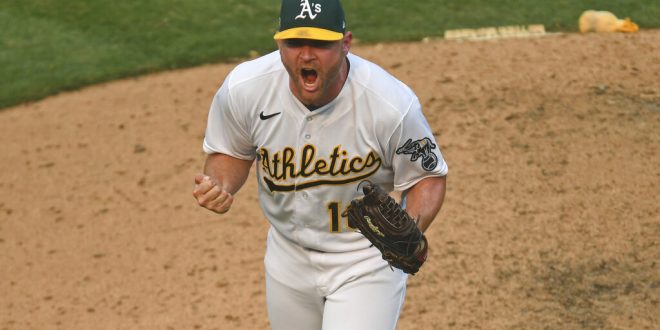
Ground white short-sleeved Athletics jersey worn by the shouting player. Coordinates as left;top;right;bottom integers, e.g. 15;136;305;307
203;51;447;252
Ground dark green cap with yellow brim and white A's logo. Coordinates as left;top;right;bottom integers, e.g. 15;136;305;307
273;0;346;41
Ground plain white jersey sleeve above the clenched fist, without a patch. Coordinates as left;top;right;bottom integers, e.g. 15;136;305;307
203;77;256;160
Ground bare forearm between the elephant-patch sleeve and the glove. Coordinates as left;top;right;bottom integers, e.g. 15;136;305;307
406;176;447;232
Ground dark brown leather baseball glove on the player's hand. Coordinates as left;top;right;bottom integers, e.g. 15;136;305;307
344;181;428;275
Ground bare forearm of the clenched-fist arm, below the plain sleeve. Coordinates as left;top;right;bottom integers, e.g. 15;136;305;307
204;154;253;195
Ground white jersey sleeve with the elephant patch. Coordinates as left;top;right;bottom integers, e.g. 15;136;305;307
388;98;448;191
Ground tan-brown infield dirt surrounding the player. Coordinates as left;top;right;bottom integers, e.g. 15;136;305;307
0;31;660;330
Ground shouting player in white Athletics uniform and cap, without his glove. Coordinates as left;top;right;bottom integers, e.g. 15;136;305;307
193;0;447;330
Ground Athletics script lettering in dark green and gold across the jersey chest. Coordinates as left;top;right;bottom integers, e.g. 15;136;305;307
259;144;382;191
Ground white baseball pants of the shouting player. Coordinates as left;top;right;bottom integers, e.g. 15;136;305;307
265;228;407;330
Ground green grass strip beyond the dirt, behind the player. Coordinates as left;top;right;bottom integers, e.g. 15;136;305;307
0;0;660;108
